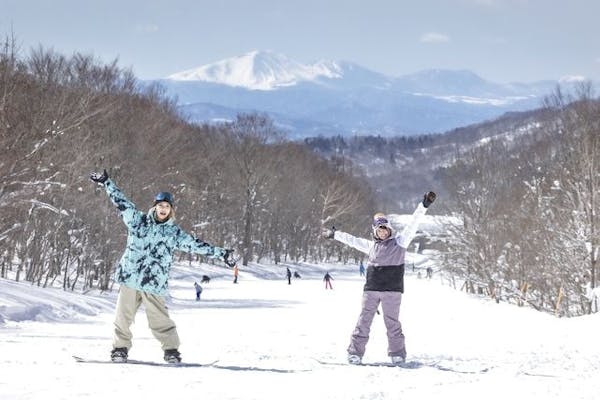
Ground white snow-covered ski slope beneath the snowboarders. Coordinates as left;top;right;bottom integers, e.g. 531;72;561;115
0;256;600;400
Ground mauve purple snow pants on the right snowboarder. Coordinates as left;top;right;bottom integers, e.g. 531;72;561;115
348;290;406;358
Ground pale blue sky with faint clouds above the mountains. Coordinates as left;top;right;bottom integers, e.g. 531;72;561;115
0;0;600;82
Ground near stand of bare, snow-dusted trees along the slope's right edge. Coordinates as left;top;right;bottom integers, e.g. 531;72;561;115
440;82;600;316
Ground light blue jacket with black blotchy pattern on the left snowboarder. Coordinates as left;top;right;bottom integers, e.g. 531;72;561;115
104;179;225;296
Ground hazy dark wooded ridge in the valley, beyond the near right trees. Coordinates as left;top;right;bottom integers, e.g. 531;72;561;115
303;108;552;214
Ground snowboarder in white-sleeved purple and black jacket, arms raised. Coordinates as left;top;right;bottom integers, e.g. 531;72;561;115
323;192;436;364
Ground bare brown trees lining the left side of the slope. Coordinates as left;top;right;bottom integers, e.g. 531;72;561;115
0;36;373;290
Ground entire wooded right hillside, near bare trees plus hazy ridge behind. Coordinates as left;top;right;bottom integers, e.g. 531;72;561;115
305;89;600;316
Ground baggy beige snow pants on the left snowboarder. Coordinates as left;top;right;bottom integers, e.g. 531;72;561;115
113;285;179;350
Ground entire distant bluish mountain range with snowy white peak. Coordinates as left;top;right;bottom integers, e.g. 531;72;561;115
152;51;573;138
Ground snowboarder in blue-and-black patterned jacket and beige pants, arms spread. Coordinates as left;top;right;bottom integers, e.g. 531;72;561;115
90;170;235;363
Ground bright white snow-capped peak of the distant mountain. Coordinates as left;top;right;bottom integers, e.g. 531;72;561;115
167;50;341;90
